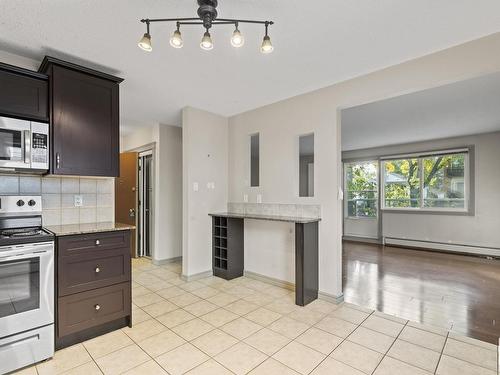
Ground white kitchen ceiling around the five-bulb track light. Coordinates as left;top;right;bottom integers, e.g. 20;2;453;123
0;0;500;134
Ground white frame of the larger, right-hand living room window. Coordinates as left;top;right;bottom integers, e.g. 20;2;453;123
379;147;474;215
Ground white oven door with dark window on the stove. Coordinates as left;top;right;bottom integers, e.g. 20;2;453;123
0;242;54;338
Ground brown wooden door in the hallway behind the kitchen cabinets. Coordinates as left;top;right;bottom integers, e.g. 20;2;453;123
115;152;138;258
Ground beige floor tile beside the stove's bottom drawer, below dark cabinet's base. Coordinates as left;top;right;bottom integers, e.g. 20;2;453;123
36;344;92;375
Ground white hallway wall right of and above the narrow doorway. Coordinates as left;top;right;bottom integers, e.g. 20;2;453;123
120;124;182;263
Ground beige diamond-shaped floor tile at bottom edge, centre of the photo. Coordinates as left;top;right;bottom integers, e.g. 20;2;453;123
215;342;268;375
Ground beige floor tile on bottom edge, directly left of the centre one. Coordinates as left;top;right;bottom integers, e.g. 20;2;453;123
156;343;209;375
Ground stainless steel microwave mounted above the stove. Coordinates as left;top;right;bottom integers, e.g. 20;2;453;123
0;117;49;173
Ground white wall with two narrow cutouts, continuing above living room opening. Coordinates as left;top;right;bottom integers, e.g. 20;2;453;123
229;34;500;296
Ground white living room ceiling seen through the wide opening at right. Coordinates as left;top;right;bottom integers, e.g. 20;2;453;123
342;73;500;151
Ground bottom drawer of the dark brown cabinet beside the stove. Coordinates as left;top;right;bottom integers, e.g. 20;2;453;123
57;282;131;337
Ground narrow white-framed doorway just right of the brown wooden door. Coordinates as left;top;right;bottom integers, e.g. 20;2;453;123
137;150;154;258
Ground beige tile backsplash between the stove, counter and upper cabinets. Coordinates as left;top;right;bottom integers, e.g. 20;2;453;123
0;175;114;225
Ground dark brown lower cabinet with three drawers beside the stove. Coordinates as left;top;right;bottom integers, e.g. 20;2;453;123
56;230;132;349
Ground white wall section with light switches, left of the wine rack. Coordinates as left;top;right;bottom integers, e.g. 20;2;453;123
182;108;228;277
